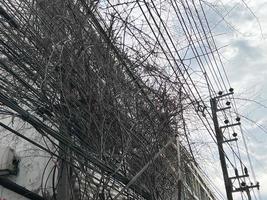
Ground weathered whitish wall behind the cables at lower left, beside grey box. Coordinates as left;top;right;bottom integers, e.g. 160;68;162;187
0;119;56;200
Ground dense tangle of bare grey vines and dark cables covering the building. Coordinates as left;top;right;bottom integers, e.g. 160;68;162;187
0;0;209;199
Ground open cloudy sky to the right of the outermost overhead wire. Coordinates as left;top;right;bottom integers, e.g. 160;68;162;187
210;0;267;200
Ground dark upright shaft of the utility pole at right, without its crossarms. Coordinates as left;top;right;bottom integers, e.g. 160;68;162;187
210;97;233;200
